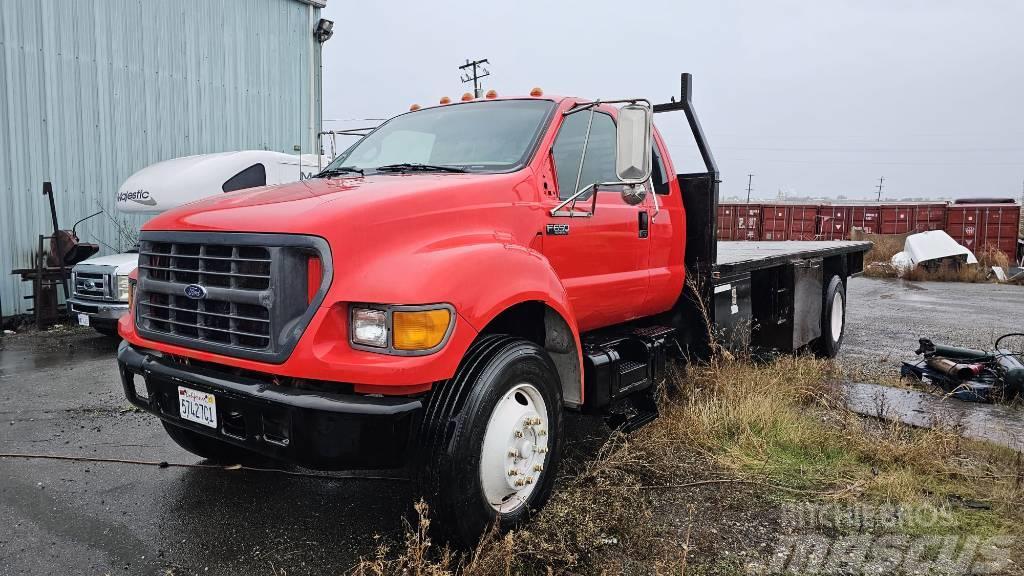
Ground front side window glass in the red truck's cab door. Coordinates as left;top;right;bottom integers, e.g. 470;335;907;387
552;112;618;200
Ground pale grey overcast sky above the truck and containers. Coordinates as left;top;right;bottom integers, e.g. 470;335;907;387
323;0;1024;199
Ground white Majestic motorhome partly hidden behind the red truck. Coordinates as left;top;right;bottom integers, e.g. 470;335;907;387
68;150;326;336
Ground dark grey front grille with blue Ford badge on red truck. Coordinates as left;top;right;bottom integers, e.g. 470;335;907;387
135;232;332;363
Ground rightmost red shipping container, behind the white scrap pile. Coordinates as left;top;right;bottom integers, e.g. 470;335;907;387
945;204;1021;254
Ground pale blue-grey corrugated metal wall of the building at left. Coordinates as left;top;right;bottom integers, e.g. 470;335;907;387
0;0;319;315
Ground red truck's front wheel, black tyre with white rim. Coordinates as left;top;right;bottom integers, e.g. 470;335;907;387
420;336;562;546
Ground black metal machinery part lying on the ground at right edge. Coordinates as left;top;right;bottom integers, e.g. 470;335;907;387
900;333;1024;402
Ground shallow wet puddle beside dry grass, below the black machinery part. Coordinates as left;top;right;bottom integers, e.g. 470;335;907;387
843;382;1024;451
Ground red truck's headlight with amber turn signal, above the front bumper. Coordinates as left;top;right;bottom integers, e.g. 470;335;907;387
350;304;455;356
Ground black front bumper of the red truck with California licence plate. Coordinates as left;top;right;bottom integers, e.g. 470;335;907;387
118;342;423;470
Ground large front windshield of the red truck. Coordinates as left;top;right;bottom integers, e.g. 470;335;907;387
325;99;555;173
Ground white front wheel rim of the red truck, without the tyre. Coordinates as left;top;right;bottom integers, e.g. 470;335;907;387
480;382;549;513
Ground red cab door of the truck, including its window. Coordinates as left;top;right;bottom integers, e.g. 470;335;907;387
542;111;649;331
